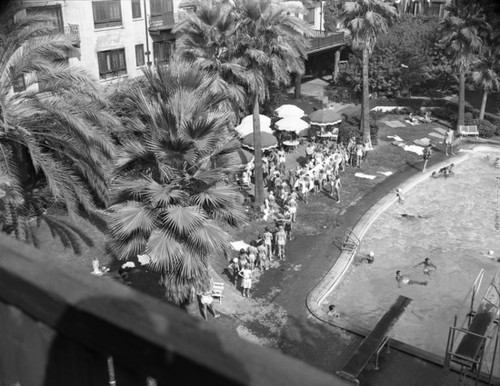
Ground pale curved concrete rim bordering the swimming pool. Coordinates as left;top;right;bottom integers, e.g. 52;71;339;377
306;143;500;382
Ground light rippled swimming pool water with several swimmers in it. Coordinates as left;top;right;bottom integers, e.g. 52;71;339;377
325;151;500;376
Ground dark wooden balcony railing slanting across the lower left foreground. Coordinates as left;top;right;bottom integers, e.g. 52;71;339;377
0;235;347;386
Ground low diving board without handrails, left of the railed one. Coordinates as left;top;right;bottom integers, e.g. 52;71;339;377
337;296;412;384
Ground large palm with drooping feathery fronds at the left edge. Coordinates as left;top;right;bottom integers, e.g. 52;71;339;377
0;14;117;252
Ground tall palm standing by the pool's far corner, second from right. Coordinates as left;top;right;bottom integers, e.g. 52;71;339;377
441;0;490;130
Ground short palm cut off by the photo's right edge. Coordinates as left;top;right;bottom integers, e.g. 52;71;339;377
472;33;500;119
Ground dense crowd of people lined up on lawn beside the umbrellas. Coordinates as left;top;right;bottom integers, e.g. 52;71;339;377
228;137;372;297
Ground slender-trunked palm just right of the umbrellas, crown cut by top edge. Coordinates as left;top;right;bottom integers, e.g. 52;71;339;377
342;0;398;141
